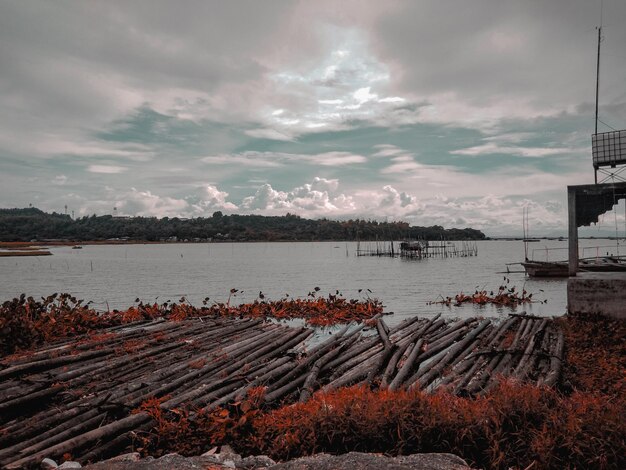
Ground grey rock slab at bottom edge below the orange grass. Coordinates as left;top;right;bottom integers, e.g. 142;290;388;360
272;452;470;470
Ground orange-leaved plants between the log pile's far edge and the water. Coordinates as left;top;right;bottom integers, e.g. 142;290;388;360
0;289;383;356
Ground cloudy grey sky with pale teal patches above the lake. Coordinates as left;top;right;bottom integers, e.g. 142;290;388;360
0;0;626;236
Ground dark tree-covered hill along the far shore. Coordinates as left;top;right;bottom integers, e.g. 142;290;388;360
0;208;485;241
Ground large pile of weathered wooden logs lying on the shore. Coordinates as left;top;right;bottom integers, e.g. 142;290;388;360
0;316;563;468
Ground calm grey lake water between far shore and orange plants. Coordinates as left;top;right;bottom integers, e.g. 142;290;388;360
0;240;624;324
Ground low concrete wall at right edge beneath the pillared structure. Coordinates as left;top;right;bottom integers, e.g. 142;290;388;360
567;273;626;319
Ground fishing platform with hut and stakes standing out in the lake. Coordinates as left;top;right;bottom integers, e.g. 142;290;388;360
356;240;478;259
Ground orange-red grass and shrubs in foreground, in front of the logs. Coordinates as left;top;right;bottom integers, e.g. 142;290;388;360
135;381;626;468
